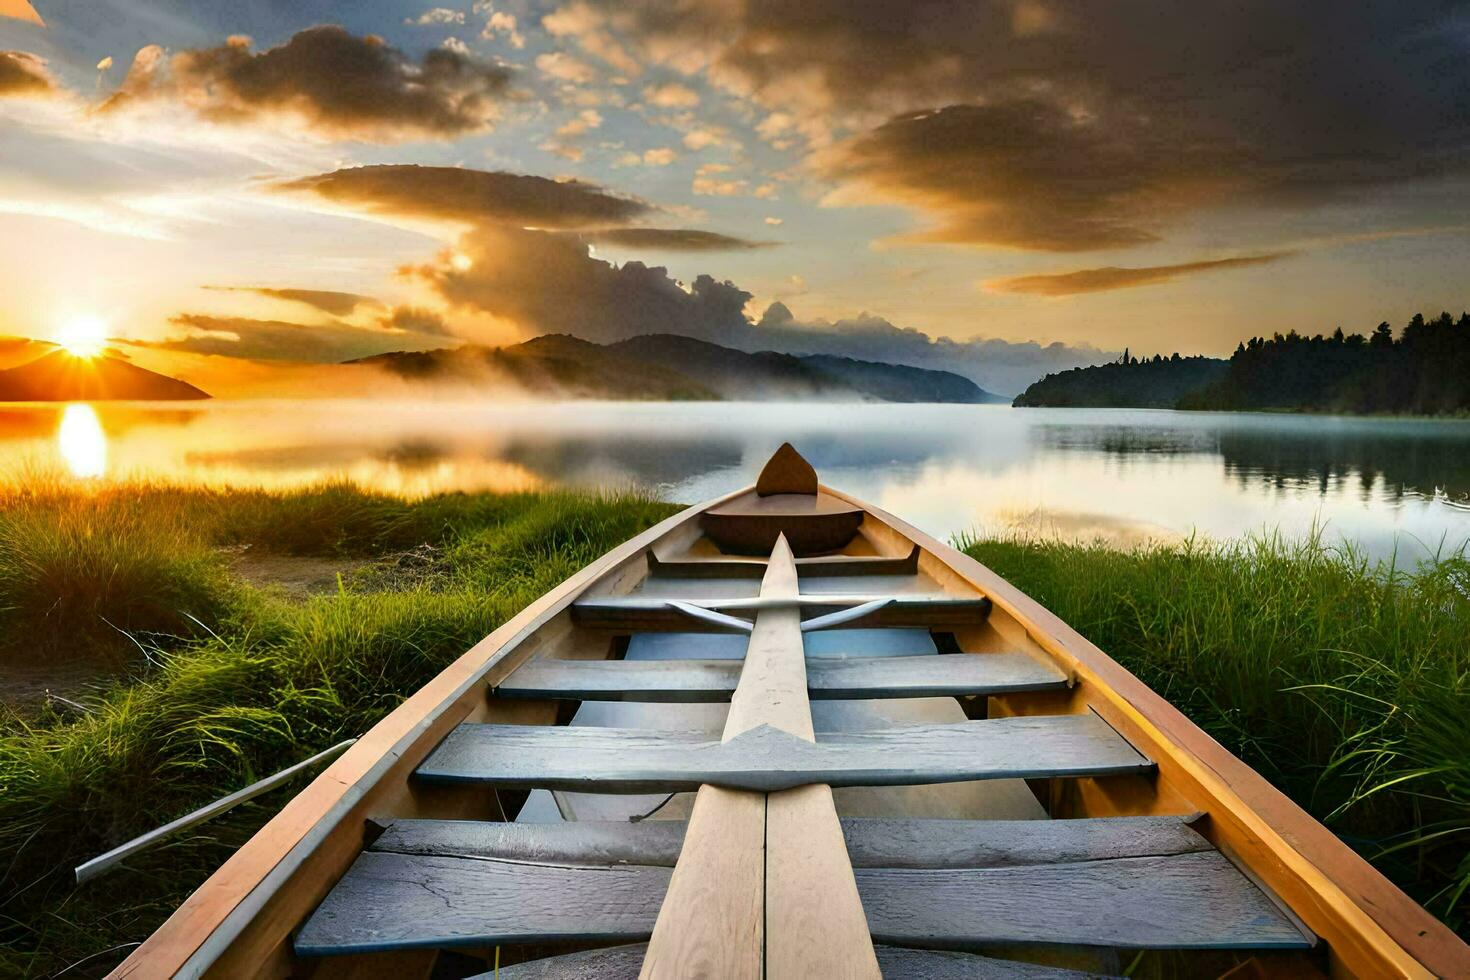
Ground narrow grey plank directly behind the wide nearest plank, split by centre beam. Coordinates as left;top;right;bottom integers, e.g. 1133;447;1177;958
372;817;1211;868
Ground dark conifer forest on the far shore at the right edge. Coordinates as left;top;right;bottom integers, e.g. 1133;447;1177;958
1014;313;1470;416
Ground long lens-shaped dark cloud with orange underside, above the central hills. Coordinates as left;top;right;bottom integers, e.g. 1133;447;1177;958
273;165;656;229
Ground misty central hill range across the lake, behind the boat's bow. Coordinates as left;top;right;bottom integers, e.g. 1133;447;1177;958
350;334;1004;404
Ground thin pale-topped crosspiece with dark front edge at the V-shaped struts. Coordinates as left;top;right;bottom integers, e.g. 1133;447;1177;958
572;595;991;633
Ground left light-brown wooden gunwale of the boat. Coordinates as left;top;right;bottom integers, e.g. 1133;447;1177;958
109;488;750;979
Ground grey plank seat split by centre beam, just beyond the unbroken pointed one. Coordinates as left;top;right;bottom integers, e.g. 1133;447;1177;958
494;654;1067;701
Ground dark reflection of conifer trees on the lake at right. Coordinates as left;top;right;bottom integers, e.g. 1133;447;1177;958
1220;429;1470;502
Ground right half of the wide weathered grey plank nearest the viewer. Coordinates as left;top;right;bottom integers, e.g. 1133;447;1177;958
857;851;1311;949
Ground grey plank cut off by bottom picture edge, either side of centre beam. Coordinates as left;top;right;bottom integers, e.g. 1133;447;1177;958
470;943;1104;980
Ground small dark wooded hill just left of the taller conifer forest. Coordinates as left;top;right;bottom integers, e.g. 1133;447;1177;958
1011;353;1229;408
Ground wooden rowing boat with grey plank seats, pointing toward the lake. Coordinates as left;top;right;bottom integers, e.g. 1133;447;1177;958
113;447;1470;980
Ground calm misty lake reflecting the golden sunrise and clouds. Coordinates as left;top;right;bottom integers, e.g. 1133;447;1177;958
0;401;1470;558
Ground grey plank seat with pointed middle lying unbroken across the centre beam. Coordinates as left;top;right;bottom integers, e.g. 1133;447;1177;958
415;714;1152;793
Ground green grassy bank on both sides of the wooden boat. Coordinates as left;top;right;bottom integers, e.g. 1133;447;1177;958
0;483;1470;977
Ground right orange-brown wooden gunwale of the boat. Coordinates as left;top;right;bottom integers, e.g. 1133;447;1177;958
822;486;1470;977
